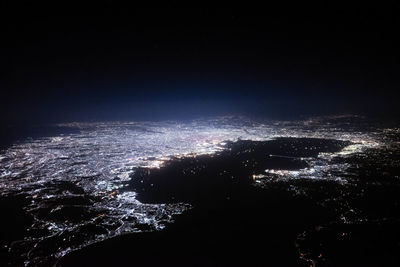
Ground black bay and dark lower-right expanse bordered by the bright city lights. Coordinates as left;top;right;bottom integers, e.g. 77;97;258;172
58;138;400;266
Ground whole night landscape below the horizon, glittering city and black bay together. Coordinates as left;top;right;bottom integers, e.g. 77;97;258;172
0;116;400;266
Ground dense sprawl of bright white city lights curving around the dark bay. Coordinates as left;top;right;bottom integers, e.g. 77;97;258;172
0;117;386;264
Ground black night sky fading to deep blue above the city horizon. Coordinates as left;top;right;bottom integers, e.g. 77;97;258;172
0;3;400;123
